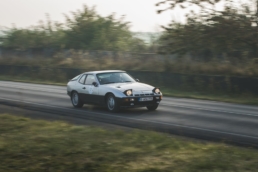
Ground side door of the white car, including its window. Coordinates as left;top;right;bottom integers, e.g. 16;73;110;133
85;74;99;104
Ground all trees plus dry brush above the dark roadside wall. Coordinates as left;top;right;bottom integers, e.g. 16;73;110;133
0;0;258;77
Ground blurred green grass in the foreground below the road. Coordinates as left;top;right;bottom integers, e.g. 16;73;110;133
0;114;258;172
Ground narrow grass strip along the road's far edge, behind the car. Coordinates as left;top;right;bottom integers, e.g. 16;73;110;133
0;76;258;105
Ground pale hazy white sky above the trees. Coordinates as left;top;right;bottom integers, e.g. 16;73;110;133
0;0;183;32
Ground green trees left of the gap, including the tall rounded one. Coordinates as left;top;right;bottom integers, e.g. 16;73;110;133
0;5;147;52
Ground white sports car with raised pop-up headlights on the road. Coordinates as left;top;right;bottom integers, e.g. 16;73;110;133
67;70;162;112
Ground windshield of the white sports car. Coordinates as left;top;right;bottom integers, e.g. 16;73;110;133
97;72;135;85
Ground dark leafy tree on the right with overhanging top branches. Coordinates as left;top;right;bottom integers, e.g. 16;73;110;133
157;0;258;59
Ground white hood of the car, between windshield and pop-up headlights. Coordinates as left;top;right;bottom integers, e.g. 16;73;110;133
103;82;154;92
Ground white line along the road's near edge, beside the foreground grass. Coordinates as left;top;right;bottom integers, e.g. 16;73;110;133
0;98;258;139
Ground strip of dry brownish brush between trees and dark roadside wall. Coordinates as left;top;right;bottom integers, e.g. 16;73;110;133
0;55;258;77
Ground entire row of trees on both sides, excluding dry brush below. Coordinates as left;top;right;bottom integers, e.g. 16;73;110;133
0;0;258;63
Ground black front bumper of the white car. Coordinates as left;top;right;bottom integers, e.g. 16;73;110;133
117;95;162;107
